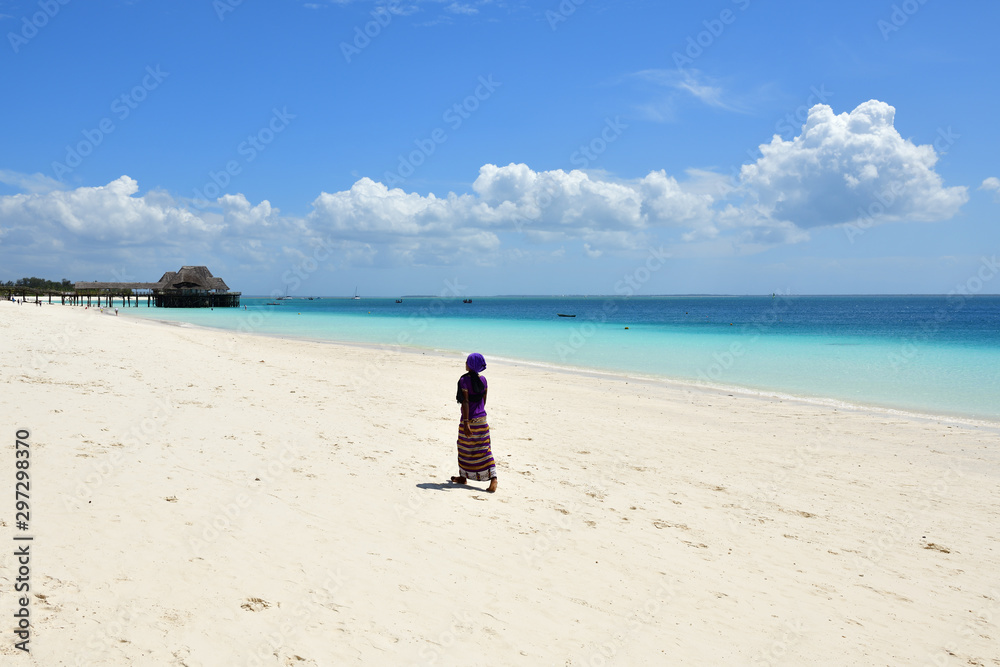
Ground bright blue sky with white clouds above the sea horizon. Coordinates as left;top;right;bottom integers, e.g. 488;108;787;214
0;0;1000;296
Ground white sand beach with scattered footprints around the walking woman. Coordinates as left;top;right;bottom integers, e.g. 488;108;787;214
0;302;1000;667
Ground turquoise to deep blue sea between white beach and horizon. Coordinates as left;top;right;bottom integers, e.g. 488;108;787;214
115;295;1000;421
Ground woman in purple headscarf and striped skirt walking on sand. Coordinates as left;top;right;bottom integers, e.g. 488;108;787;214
451;352;497;493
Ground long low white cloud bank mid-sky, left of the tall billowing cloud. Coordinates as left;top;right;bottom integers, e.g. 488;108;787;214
305;164;714;261
